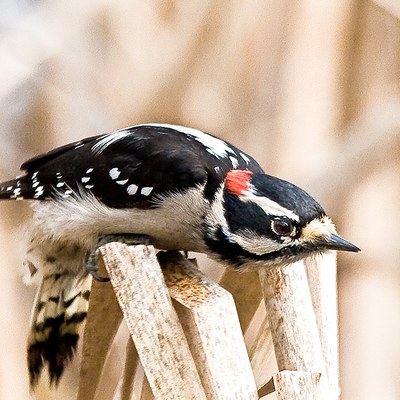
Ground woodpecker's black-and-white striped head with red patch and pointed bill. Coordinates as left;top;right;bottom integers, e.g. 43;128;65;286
206;170;359;268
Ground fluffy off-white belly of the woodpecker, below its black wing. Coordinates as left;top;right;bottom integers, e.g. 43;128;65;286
32;188;210;252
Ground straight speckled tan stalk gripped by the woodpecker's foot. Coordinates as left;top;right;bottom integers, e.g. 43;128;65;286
100;243;206;400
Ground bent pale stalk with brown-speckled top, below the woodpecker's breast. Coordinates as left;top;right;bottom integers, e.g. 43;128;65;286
159;252;258;400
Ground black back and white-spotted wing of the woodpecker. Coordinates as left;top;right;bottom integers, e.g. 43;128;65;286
0;125;262;208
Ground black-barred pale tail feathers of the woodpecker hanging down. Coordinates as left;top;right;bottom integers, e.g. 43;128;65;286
28;273;92;388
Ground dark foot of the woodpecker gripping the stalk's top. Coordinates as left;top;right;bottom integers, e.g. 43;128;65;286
86;233;150;282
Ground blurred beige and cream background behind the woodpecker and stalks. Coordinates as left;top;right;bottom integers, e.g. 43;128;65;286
0;0;400;400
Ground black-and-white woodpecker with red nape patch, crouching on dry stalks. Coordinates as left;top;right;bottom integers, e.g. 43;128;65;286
0;124;359;388
